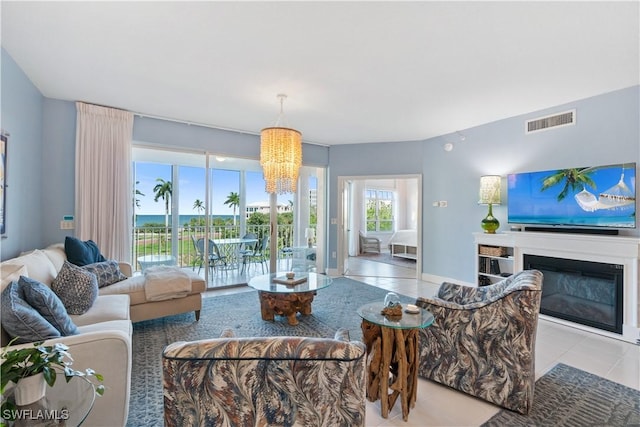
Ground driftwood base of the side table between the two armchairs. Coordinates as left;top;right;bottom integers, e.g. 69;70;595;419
362;319;418;421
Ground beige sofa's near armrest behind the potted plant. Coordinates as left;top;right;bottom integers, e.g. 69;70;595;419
4;330;132;426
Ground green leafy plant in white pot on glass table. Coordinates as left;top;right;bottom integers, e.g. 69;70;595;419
0;338;105;414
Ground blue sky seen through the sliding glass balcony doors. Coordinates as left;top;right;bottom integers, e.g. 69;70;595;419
135;162;308;215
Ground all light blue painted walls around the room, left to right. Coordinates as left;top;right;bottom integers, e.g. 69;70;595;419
2;46;640;288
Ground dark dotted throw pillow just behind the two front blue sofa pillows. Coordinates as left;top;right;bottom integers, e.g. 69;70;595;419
51;261;98;314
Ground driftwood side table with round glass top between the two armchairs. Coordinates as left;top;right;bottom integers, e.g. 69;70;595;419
358;302;433;421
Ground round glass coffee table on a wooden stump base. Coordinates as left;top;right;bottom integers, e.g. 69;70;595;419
249;272;333;325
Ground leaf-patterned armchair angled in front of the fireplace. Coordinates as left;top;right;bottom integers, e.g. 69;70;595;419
416;270;543;414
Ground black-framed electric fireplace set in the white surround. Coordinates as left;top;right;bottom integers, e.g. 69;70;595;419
523;254;624;334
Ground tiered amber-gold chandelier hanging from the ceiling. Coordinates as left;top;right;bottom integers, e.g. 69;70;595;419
260;94;302;194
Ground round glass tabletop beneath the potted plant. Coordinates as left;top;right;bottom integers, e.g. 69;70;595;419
0;380;96;427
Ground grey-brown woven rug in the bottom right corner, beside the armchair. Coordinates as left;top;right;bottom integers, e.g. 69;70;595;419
482;363;640;427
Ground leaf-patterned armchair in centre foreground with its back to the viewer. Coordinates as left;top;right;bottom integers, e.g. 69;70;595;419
162;329;366;427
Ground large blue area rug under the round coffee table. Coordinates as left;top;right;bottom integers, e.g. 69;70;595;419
127;278;415;427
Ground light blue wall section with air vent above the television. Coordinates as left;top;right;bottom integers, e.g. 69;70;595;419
423;86;640;282
